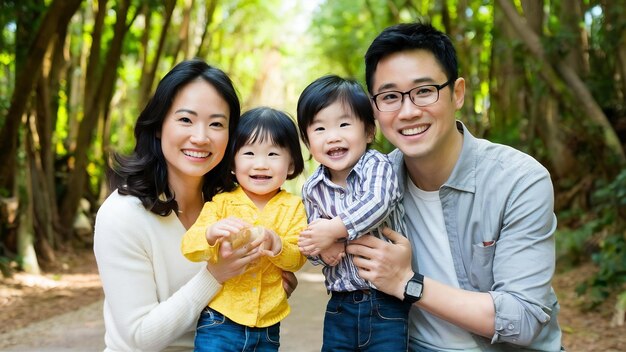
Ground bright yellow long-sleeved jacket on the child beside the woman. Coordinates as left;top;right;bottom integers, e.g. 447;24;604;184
181;187;307;327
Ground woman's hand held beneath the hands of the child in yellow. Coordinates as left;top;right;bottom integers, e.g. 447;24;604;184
206;236;261;284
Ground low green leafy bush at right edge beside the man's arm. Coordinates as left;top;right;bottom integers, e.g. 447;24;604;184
577;169;626;306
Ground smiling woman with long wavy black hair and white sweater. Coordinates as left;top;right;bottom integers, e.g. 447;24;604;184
94;60;268;351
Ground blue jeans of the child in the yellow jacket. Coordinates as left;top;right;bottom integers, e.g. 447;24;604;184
194;307;280;352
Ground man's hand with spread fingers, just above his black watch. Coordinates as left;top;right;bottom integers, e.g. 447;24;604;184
346;228;413;299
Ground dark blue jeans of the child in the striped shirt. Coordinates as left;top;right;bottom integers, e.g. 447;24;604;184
322;290;411;351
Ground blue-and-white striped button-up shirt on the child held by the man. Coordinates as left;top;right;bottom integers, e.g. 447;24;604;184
302;150;406;291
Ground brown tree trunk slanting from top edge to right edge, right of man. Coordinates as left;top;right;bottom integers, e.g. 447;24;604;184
498;0;626;164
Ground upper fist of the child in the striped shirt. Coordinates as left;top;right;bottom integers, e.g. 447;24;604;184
298;217;348;256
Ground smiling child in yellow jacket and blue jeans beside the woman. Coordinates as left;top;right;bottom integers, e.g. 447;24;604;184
181;107;307;351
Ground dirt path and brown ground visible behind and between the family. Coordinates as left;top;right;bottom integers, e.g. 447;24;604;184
0;251;626;352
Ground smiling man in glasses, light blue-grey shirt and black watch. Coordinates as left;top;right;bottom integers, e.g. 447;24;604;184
347;23;561;351
